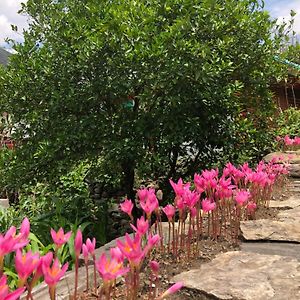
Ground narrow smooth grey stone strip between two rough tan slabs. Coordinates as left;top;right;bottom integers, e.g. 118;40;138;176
240;242;300;261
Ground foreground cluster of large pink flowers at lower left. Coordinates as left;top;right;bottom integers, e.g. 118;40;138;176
0;217;182;300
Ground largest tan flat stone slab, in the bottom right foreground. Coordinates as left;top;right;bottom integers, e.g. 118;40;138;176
172;251;300;300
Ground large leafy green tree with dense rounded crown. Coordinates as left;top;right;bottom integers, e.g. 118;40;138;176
0;0;280;204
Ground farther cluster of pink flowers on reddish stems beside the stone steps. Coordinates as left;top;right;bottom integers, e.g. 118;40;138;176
121;159;288;247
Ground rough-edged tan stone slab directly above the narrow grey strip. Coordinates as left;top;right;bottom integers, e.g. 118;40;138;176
240;207;300;243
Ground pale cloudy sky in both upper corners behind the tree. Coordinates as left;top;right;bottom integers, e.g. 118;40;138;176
0;0;300;48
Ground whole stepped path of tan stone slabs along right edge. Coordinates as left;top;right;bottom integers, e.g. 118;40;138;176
172;164;300;300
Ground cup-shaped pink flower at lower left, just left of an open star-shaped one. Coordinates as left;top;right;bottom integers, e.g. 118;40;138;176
15;249;40;285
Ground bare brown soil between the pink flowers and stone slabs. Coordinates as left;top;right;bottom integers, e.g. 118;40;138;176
80;179;291;300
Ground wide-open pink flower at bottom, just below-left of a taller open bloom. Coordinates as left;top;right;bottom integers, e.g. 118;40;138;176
96;253;129;282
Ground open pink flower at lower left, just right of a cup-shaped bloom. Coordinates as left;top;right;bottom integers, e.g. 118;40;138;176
42;258;69;287
